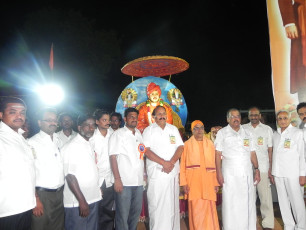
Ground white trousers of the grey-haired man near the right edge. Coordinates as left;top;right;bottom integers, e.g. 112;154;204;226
274;177;306;230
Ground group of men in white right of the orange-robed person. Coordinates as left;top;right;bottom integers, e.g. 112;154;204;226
215;103;306;230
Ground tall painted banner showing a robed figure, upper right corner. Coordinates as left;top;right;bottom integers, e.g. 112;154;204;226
266;0;306;125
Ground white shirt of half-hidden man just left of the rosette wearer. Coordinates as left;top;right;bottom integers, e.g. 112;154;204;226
89;128;112;188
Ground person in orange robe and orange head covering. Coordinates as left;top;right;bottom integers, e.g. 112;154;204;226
180;120;219;230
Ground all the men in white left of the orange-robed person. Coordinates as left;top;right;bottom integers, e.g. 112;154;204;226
0;97;184;230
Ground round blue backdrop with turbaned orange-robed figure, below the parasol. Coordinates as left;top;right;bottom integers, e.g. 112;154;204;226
116;76;188;132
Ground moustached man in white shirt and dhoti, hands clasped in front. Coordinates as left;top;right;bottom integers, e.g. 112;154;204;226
143;106;184;230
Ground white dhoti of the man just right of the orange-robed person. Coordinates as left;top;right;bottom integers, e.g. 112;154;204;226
222;166;256;230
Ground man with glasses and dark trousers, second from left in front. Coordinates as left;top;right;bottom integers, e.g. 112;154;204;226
28;108;64;230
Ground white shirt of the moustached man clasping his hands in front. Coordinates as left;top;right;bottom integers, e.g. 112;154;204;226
143;123;184;178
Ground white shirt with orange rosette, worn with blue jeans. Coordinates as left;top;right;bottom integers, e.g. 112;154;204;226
109;126;144;186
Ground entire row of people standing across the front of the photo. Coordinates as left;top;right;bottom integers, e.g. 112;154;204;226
0;97;306;230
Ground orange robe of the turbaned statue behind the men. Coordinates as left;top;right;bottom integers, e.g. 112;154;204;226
137;103;173;133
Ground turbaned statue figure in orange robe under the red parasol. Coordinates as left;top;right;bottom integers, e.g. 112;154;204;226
137;82;173;133
